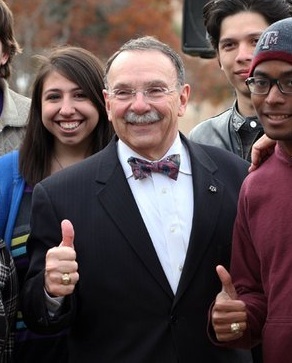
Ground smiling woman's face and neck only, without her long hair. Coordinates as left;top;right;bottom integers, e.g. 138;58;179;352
42;71;99;172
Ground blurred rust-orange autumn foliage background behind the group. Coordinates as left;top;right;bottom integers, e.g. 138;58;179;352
6;0;231;104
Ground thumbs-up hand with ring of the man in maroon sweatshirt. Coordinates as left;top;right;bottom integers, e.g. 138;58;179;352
211;265;247;342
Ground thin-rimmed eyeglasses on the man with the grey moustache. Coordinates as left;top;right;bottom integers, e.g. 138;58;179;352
107;87;177;103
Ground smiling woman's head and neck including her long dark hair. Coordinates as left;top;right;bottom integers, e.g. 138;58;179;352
19;46;113;185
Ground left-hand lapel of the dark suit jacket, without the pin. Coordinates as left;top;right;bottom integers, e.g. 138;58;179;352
97;142;173;298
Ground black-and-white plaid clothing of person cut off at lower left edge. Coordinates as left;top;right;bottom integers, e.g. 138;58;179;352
0;239;18;363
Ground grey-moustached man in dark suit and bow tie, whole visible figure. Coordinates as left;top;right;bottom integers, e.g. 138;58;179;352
21;36;251;363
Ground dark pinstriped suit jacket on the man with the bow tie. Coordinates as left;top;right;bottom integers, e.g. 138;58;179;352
22;136;249;363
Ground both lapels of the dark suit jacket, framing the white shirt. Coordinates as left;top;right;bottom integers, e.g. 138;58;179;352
96;136;224;305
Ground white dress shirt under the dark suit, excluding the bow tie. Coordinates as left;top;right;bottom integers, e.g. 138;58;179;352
117;134;194;294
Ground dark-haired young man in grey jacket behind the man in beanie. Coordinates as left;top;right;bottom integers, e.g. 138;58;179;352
189;0;291;161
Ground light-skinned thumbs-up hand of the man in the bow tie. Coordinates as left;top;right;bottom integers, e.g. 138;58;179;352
45;219;79;297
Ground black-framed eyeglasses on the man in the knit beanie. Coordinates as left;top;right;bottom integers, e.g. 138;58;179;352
245;77;292;95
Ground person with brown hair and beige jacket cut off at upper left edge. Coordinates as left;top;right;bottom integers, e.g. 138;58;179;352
0;0;30;155
